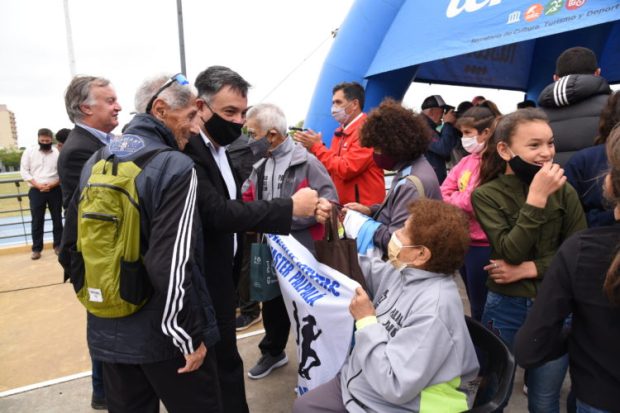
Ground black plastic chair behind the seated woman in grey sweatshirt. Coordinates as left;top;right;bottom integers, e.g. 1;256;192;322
465;316;517;413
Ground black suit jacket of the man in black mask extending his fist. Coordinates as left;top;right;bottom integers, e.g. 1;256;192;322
185;135;293;292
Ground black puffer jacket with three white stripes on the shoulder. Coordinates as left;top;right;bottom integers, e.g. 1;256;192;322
538;75;611;166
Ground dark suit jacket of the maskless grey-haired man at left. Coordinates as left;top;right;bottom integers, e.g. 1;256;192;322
58;125;105;209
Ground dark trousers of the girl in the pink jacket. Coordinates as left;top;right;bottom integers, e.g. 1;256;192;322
461;246;491;321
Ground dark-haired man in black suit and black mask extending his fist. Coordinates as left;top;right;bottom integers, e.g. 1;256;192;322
185;66;318;413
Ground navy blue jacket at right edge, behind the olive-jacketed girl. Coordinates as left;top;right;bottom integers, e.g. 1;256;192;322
564;145;615;228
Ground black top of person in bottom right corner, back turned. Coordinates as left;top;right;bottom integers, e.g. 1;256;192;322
515;221;620;412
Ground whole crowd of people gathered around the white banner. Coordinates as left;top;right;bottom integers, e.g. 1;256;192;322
21;43;620;413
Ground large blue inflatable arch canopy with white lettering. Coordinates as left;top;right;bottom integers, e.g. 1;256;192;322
306;0;620;143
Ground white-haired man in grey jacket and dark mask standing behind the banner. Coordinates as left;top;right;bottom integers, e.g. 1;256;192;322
243;103;338;379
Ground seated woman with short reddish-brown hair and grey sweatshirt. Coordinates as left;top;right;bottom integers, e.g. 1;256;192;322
293;199;479;413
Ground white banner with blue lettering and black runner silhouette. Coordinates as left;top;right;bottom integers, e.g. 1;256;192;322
267;234;359;395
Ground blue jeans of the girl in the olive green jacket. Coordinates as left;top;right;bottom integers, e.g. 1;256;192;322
482;291;568;413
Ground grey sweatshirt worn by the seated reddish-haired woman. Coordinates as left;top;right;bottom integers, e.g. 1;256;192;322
340;256;479;413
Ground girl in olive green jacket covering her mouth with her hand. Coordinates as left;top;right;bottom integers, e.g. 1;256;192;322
472;109;586;413
